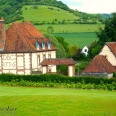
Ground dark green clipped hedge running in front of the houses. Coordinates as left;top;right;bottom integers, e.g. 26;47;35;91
0;74;116;85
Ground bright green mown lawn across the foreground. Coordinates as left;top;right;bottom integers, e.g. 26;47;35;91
0;86;116;116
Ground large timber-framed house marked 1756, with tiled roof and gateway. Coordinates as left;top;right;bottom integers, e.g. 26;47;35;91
0;18;75;76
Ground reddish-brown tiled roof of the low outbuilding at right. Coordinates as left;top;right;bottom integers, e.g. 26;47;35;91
83;55;115;73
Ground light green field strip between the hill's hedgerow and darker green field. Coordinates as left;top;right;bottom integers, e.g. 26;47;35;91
35;24;104;33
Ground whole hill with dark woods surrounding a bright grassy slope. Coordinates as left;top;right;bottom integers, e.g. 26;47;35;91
0;0;108;24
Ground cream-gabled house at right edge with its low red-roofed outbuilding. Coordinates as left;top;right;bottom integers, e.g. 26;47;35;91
82;42;116;78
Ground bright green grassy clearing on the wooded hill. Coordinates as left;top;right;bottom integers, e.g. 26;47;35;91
22;5;79;23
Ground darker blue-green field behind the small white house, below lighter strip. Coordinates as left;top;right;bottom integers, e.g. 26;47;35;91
54;33;98;48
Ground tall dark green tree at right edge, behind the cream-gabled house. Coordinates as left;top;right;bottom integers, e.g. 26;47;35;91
96;13;116;46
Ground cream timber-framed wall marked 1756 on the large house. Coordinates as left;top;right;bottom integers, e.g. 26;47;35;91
0;51;56;74
